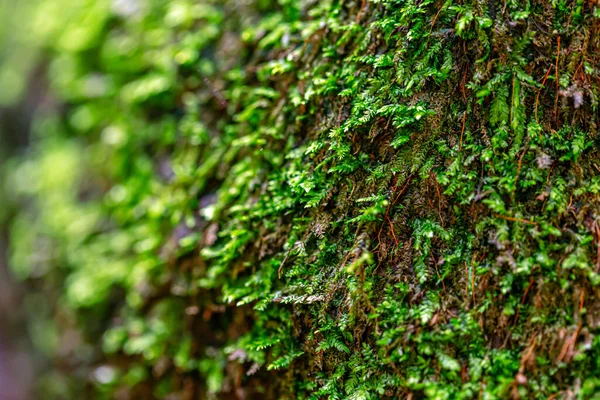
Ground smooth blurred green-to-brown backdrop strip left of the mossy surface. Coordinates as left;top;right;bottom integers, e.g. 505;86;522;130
0;0;51;400
